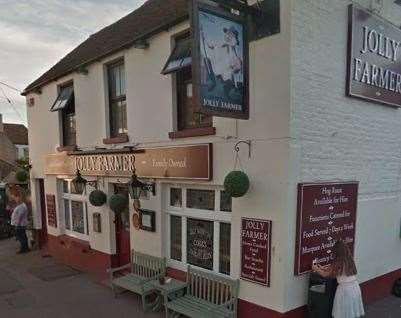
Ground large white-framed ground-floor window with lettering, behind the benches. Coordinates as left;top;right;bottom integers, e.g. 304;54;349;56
167;187;231;275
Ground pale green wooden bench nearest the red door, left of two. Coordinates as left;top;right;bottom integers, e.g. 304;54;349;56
108;251;166;311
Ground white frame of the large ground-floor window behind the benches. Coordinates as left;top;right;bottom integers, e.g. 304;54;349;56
164;185;232;276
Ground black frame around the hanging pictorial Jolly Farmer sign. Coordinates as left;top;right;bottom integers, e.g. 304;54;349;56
189;0;249;119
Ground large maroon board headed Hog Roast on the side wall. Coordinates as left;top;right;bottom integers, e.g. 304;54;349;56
295;182;358;275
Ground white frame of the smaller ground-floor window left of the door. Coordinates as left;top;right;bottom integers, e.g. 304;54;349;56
59;179;89;241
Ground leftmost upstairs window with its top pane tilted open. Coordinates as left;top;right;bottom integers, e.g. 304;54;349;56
50;84;77;146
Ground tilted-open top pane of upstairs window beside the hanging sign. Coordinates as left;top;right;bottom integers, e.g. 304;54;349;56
162;38;192;75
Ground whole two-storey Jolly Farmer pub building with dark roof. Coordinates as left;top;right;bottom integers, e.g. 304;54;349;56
23;0;401;317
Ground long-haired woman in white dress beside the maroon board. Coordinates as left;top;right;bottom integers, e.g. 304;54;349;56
312;241;365;318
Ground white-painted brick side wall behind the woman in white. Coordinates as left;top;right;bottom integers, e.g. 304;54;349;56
285;0;401;310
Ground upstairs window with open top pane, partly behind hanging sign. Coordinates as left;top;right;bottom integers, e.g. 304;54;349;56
162;34;212;131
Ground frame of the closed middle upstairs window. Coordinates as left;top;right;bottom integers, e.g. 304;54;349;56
106;57;128;138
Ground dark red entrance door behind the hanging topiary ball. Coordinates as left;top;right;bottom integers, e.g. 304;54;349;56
114;184;131;266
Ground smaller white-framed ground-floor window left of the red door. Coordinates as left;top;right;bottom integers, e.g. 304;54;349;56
62;180;89;239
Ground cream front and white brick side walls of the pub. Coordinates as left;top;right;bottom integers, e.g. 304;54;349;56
28;0;401;312
